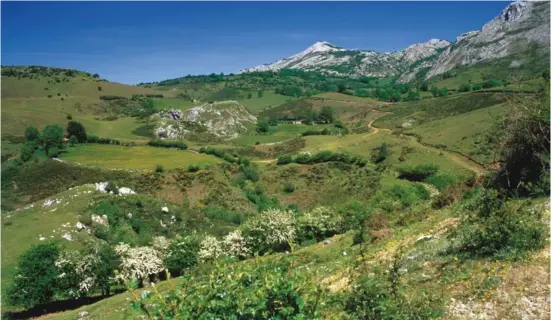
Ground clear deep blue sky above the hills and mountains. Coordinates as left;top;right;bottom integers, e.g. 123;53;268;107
1;1;507;84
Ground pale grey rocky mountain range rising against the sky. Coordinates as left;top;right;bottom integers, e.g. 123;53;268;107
241;1;549;82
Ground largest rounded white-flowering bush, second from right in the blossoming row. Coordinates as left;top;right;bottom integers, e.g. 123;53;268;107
242;209;296;253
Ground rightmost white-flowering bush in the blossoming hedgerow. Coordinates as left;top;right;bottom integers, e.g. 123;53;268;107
297;207;343;241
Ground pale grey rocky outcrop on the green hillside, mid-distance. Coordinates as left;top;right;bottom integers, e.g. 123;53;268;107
152;101;256;139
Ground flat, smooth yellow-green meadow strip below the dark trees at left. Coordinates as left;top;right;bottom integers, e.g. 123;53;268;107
62;144;221;170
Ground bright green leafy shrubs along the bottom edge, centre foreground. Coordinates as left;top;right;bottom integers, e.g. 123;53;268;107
132;260;324;319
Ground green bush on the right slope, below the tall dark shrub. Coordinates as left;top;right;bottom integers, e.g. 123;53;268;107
450;189;548;258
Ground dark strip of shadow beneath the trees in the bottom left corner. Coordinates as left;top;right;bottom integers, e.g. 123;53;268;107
2;293;122;320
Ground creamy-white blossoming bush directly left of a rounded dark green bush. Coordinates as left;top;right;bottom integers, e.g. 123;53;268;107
115;243;164;282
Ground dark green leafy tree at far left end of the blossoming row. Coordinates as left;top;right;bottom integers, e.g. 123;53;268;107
6;243;60;308
